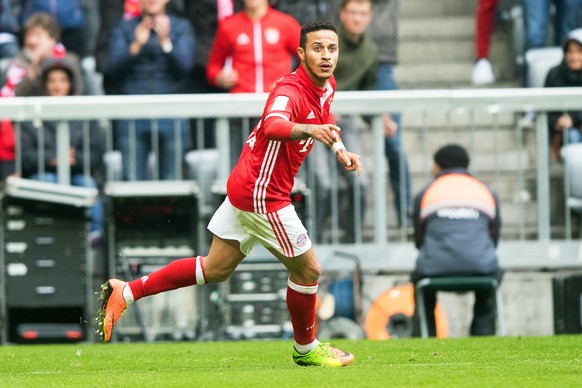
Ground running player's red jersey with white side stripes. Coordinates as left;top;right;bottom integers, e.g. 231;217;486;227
226;66;335;213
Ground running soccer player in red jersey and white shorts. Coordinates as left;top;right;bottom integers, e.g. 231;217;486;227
97;20;362;366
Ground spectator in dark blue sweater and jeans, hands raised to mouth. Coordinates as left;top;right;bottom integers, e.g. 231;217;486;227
106;0;195;180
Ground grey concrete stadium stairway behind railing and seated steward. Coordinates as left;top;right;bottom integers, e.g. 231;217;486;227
388;0;563;239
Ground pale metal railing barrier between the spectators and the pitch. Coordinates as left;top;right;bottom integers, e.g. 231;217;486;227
0;88;582;268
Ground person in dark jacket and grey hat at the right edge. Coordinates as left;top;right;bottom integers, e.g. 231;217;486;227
544;28;582;160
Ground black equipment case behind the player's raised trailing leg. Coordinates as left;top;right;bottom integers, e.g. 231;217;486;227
104;181;202;341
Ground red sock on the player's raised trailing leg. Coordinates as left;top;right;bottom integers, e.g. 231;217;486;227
128;256;206;301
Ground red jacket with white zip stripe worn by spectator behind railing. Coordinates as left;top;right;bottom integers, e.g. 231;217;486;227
206;8;301;93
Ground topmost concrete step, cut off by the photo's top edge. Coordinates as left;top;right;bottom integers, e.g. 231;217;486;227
400;0;477;19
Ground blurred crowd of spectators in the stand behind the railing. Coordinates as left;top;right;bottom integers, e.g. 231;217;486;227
0;0;582;244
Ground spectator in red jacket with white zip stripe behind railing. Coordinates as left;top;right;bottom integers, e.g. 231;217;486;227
206;0;301;166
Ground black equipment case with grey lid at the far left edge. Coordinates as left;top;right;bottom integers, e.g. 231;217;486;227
0;177;97;343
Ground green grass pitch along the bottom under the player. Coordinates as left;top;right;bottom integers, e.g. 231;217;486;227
0;335;582;388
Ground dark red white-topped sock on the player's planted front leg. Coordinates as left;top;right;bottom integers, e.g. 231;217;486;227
287;278;317;345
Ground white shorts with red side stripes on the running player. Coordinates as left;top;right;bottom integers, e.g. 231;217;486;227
208;197;311;257
